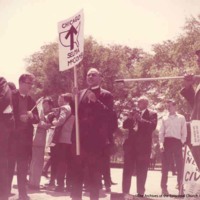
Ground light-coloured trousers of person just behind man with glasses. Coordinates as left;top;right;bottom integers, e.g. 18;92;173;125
29;146;45;187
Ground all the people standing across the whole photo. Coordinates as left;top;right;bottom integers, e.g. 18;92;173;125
0;51;200;200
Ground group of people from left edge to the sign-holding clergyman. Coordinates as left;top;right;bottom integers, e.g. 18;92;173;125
0;68;117;200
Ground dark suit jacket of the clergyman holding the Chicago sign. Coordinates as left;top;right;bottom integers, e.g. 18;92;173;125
74;88;113;153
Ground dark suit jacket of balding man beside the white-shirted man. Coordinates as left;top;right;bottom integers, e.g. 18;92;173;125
123;109;157;156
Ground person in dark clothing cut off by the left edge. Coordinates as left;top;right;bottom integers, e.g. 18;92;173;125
0;77;14;200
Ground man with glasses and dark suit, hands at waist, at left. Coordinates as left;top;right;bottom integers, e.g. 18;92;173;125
11;74;39;200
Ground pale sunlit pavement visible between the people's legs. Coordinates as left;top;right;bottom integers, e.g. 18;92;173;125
9;168;180;200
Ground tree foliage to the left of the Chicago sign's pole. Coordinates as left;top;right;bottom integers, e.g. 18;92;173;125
26;43;73;100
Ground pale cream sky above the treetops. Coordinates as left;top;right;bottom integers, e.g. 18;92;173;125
0;0;200;85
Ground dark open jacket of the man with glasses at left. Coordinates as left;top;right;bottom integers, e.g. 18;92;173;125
12;90;39;145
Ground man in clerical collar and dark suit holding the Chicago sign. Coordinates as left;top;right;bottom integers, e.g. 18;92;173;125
72;68;113;200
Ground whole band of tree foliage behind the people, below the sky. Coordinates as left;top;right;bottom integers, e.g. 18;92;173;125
26;15;200;161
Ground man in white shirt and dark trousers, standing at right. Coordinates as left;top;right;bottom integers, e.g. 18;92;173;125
159;99;187;195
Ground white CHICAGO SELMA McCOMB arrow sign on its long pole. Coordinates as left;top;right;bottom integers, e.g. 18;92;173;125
58;10;84;155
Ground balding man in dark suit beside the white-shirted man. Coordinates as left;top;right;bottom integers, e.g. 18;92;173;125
122;96;157;196
